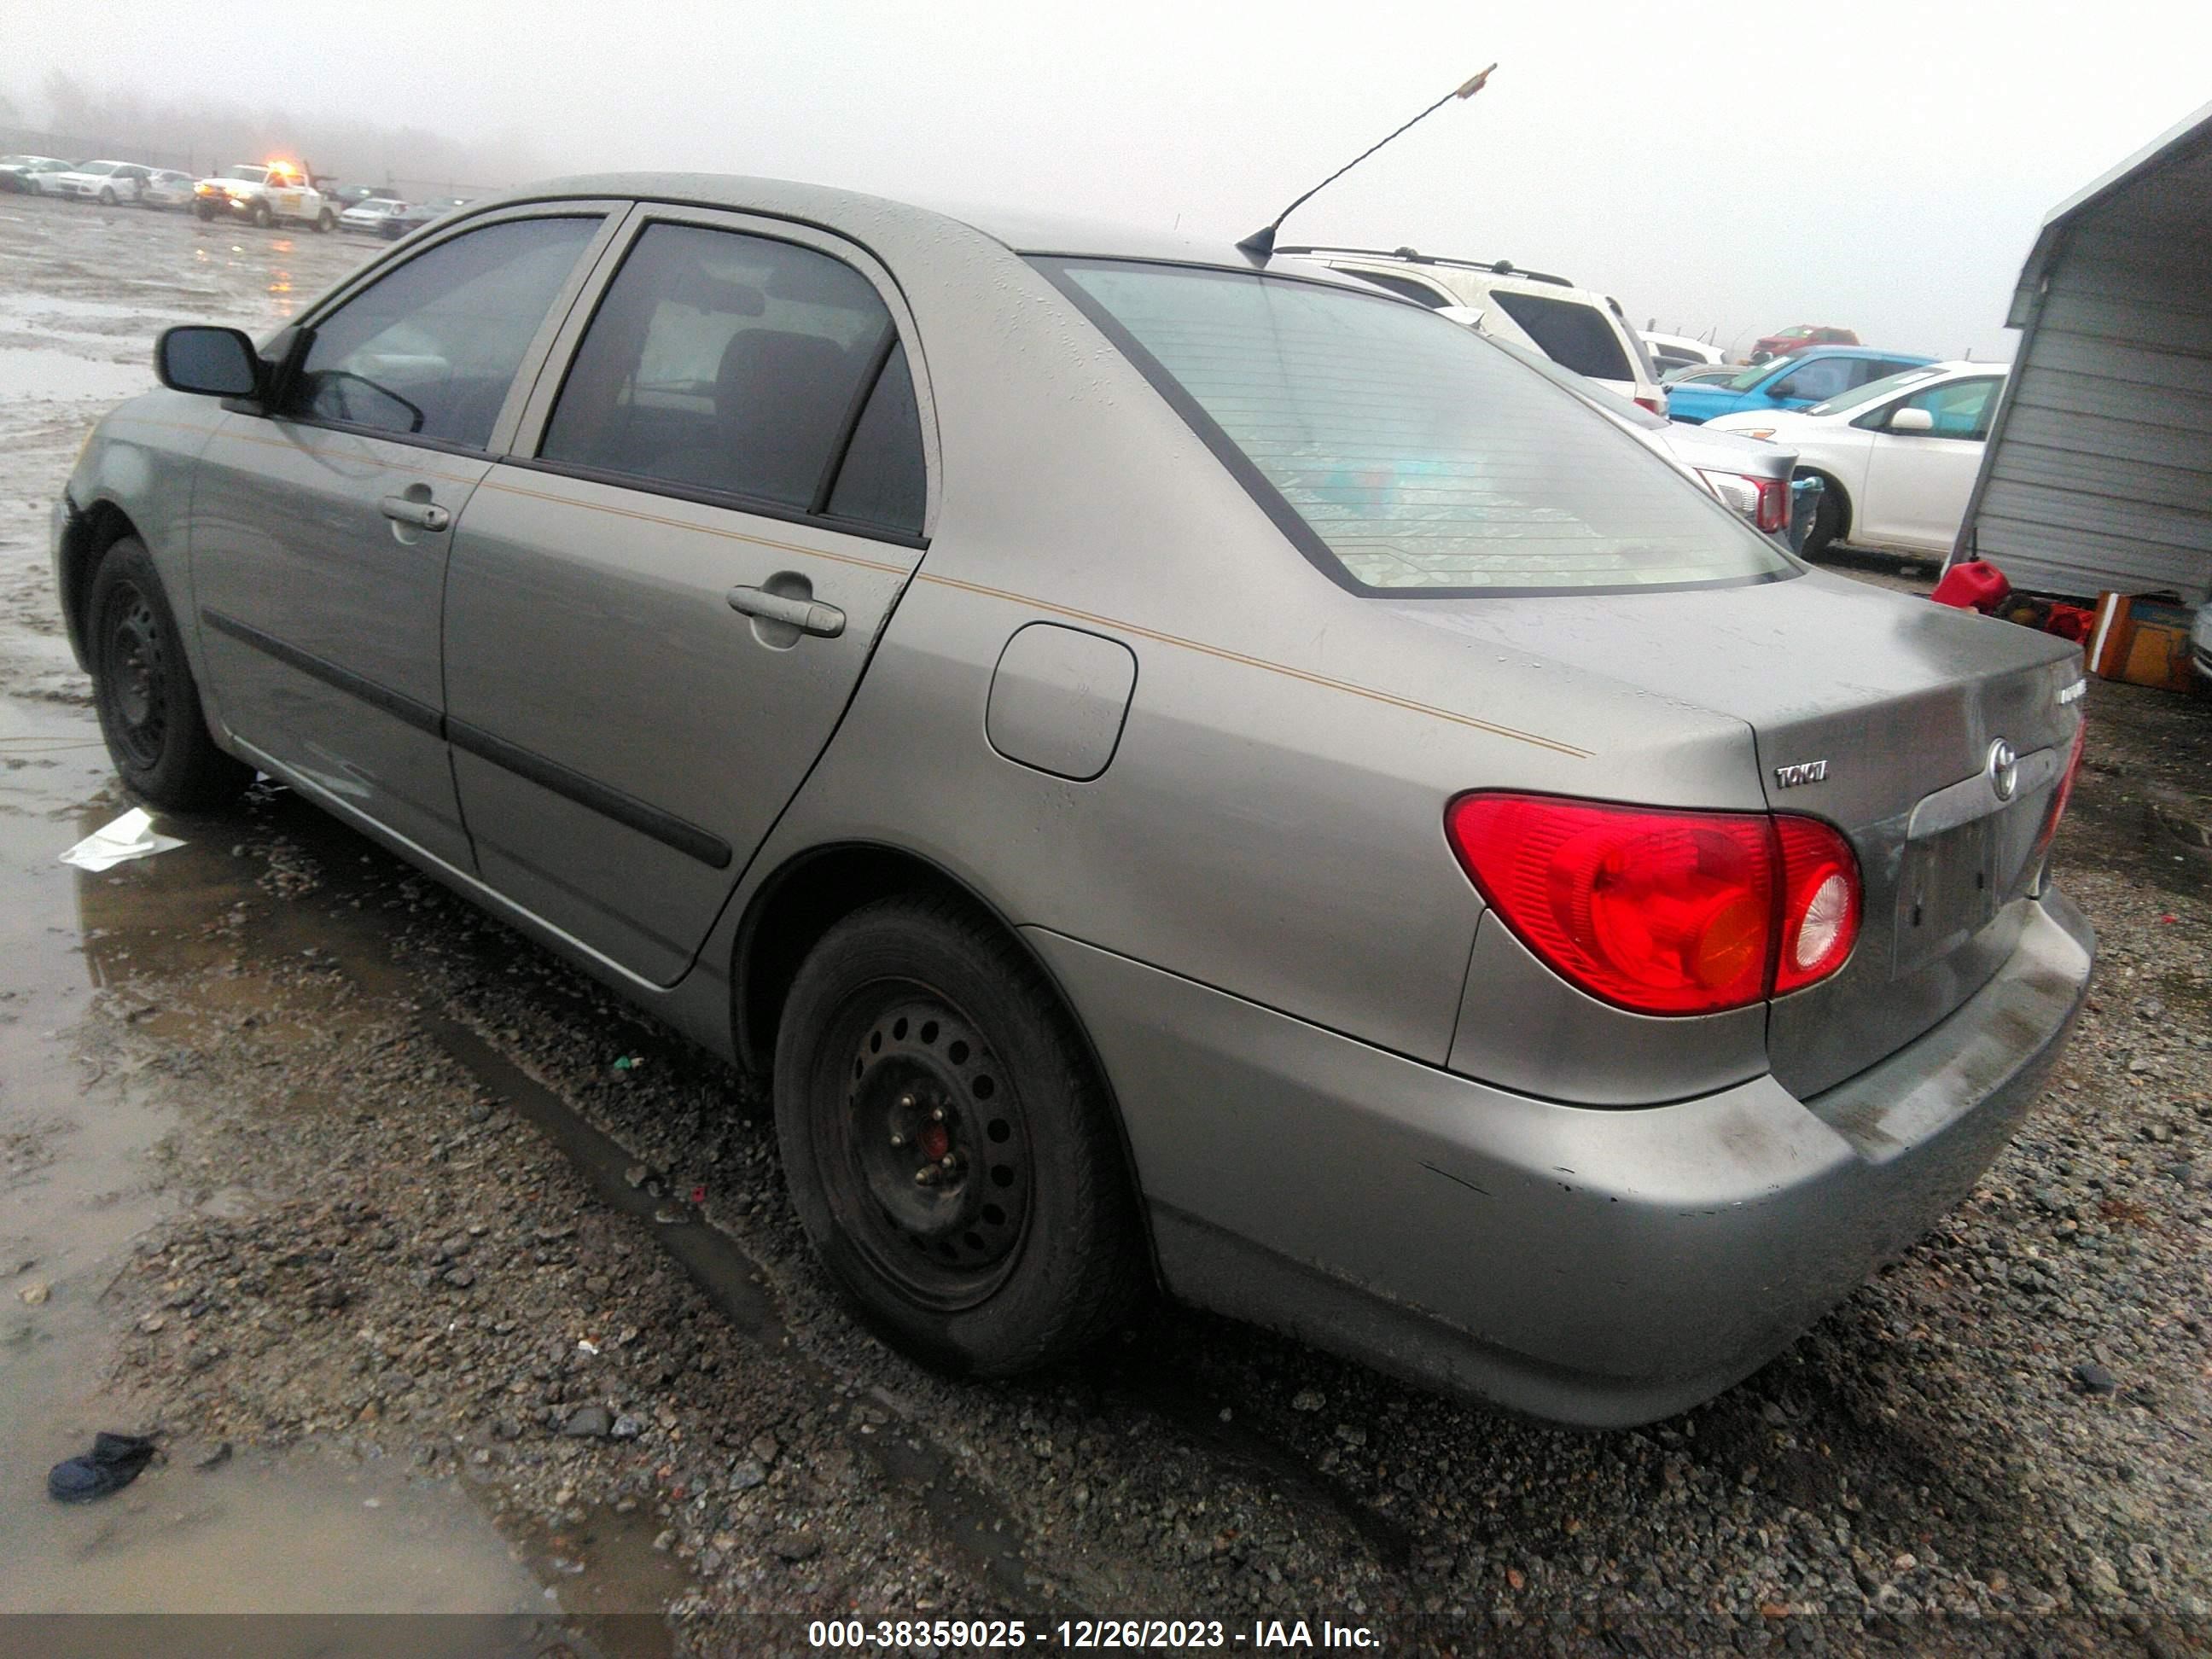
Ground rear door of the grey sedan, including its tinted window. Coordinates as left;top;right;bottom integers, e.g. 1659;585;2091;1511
447;208;927;984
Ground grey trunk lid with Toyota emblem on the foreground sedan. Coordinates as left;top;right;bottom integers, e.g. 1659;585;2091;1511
1398;571;2081;1095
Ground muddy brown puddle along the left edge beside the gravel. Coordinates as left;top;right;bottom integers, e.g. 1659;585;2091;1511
0;699;588;1655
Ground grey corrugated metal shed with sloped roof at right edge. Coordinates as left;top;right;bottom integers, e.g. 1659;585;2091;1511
1951;104;2212;604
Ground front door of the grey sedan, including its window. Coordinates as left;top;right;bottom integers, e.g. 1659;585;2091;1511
190;203;608;867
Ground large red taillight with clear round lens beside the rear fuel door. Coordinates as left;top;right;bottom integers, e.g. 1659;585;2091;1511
1445;795;1860;1013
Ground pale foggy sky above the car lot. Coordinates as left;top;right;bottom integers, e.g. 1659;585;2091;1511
0;0;2212;356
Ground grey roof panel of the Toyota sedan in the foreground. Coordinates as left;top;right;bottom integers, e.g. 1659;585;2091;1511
469;172;1305;276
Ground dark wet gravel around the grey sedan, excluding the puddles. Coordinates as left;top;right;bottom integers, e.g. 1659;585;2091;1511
0;195;2212;1655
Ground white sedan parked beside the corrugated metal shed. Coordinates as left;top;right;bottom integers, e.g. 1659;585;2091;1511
1705;363;2009;556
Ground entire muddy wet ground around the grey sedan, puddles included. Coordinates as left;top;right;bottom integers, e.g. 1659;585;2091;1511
0;197;2212;1655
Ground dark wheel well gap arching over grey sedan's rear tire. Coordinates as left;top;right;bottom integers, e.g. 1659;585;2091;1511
730;843;1159;1283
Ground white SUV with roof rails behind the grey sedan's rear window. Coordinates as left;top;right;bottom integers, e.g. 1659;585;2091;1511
1277;246;1666;416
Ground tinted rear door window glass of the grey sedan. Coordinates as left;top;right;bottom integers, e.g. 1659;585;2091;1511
538;224;918;518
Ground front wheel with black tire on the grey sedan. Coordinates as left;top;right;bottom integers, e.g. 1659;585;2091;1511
84;535;254;812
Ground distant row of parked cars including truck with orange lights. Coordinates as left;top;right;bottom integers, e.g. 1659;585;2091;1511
0;154;467;242
